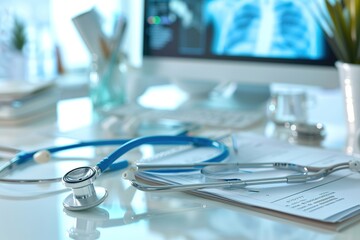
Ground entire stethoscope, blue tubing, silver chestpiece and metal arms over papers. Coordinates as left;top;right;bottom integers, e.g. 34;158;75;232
0;136;360;211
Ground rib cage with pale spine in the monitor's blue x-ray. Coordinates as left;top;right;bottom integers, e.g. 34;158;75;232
223;0;311;57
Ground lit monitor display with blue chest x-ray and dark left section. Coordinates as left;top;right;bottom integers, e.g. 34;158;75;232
144;0;328;61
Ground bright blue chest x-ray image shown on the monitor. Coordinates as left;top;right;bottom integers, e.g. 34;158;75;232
205;0;324;59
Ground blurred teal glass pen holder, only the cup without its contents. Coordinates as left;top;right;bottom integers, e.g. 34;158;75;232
89;55;127;111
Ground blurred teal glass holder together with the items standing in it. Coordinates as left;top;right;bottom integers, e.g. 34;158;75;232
73;8;127;111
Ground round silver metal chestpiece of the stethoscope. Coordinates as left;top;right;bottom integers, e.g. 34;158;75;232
62;167;108;211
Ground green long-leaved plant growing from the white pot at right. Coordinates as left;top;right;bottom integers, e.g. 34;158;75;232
317;0;360;64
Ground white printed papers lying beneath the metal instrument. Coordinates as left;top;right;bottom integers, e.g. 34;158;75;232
134;133;360;230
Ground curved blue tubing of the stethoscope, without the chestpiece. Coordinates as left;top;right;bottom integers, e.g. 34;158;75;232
0;135;229;183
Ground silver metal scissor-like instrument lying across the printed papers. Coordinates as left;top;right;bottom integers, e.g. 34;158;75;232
123;160;360;191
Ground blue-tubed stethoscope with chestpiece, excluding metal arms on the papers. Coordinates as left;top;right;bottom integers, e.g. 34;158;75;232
0;135;229;210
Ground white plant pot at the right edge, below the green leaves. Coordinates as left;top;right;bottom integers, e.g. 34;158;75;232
336;62;360;154
